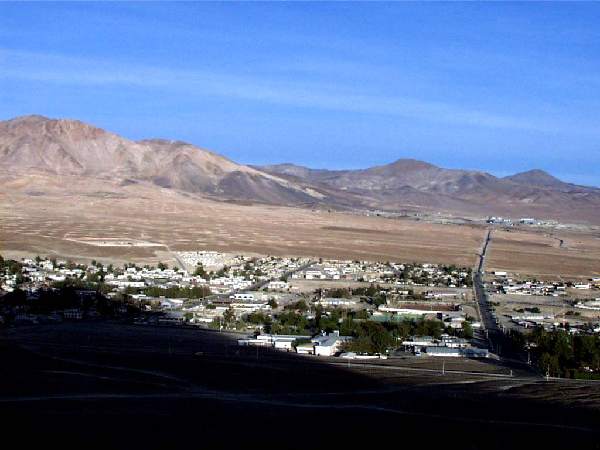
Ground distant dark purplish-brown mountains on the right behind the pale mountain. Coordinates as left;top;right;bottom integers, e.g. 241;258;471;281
257;159;600;221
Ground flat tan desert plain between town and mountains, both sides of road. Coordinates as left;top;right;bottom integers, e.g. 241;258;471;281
0;174;600;278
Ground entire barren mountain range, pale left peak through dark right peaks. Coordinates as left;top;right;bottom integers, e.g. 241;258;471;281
0;116;600;223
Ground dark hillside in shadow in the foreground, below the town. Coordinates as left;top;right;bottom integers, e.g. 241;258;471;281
0;322;600;450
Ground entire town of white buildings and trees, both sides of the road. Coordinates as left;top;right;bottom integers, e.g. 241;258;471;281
0;250;600;377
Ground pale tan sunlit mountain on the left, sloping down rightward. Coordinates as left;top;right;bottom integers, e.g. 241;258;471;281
0;116;326;204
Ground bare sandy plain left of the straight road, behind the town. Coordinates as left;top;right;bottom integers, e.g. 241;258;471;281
0;174;484;266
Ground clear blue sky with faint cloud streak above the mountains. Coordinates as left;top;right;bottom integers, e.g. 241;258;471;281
0;3;600;186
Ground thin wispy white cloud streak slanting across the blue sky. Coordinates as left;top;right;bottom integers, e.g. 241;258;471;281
0;49;592;132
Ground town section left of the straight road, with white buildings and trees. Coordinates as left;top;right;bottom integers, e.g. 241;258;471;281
0;251;488;359
